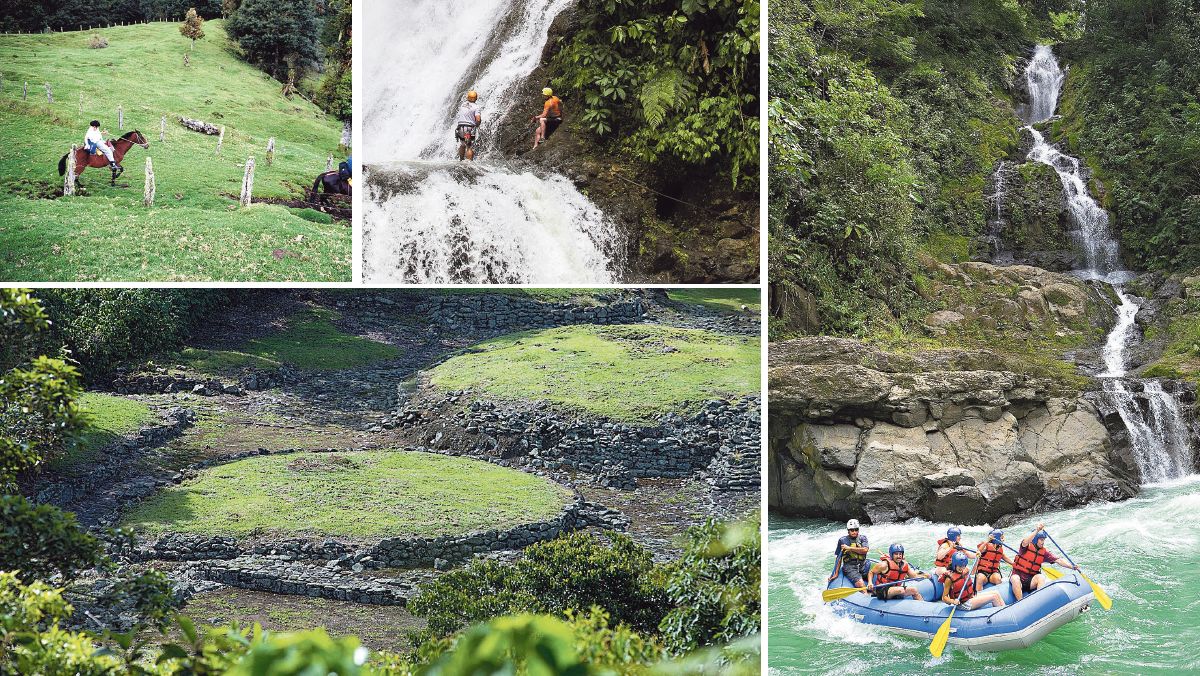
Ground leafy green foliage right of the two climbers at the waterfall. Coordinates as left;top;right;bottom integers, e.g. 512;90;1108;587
554;0;760;189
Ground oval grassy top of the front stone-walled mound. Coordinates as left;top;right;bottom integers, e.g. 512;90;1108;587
122;450;572;538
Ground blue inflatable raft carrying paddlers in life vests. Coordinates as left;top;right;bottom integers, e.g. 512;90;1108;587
828;561;1094;651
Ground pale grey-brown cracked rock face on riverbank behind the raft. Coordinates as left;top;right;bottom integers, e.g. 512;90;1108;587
768;337;1136;524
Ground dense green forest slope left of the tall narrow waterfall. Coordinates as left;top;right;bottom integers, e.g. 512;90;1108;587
768;0;1069;337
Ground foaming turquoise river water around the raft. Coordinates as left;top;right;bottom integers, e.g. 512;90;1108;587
768;474;1200;676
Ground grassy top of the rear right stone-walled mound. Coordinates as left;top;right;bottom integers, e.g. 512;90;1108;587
430;324;760;420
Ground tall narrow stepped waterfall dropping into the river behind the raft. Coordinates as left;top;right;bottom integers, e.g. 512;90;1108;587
1024;44;1195;483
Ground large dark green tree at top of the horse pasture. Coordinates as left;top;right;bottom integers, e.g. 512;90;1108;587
227;0;320;96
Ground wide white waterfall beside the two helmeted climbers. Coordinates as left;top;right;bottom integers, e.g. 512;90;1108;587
361;0;624;283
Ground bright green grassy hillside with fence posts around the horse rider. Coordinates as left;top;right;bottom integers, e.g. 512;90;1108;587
0;20;350;281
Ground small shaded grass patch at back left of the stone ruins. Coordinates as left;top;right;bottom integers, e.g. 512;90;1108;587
179;310;400;375
